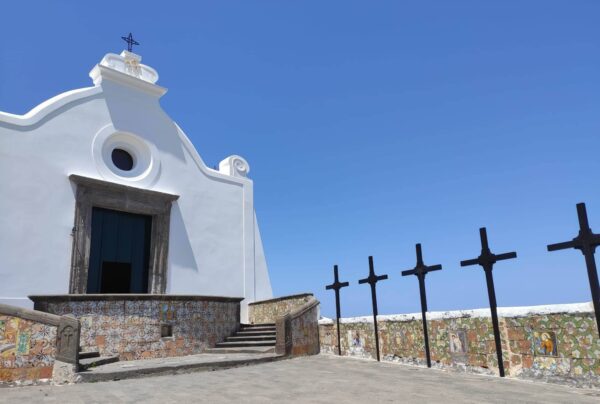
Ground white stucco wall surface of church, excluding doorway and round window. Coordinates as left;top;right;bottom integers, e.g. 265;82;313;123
0;49;272;318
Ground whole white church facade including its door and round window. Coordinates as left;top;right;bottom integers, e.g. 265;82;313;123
0;51;272;318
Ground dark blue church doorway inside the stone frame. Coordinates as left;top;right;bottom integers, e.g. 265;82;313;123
86;207;152;293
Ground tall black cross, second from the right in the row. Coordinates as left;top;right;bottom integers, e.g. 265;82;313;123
460;227;517;377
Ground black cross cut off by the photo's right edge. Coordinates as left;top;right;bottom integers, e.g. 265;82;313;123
548;203;600;336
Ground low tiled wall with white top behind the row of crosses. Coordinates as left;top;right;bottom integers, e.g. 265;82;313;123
319;303;600;388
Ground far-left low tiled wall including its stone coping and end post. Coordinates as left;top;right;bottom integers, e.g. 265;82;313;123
0;304;79;384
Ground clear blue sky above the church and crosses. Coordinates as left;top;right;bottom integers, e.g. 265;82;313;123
0;0;600;316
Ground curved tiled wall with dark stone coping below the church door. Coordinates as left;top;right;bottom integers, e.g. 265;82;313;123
30;294;242;360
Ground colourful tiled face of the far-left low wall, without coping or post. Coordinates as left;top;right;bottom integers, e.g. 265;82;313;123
0;314;56;382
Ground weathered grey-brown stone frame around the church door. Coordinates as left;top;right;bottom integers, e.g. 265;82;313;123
69;174;179;294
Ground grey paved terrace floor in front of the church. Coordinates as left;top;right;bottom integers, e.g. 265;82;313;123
0;355;600;404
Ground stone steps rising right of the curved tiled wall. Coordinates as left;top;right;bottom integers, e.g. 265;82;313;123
207;323;277;353
